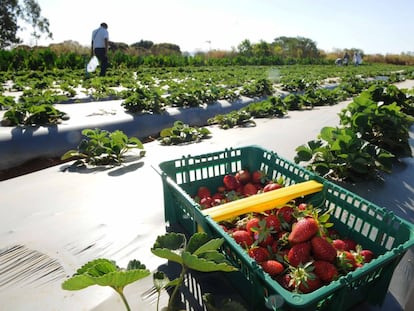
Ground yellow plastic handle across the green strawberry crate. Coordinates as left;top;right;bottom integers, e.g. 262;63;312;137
202;180;323;221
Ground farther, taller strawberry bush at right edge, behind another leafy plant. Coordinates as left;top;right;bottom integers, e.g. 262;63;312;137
340;85;414;157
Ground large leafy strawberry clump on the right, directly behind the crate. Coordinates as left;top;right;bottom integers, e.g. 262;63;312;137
294;83;414;181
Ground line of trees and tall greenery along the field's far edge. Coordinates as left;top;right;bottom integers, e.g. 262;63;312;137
0;0;414;71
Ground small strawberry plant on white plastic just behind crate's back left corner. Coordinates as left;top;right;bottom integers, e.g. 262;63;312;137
158;121;211;145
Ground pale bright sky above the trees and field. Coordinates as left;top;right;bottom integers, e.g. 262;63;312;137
22;0;414;55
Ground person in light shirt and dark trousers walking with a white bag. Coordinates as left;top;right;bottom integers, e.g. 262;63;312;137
91;23;109;77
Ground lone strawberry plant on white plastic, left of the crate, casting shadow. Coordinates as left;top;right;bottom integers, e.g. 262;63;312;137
61;129;145;166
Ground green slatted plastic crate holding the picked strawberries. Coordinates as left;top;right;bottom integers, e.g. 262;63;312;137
154;146;414;311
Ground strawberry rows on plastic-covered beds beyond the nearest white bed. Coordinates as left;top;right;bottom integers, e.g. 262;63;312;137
0;65;413;173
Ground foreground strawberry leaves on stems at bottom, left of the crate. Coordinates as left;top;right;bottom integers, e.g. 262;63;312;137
62;232;241;311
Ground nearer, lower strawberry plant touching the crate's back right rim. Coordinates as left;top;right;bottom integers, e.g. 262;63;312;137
294;127;394;181
